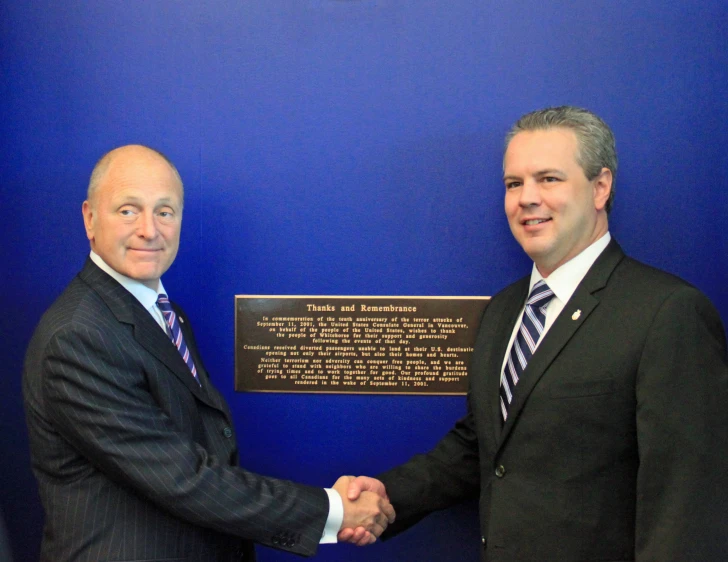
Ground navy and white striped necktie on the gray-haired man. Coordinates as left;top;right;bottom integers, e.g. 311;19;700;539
500;279;554;422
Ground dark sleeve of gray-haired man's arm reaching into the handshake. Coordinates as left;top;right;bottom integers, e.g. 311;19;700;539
377;390;480;539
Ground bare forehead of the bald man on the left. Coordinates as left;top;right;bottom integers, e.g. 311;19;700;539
98;151;183;204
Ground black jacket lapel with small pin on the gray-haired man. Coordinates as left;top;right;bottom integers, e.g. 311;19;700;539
496;240;624;446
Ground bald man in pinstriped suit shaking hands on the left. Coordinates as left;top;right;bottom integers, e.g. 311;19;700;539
23;145;394;562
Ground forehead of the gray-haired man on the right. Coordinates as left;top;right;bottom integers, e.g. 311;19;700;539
503;128;578;172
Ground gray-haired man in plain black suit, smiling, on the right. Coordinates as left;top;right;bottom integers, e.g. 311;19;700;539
340;107;728;562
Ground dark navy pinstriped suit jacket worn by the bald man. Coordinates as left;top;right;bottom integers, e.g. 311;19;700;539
23;260;328;562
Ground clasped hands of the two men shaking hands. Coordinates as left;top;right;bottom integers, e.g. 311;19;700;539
333;476;394;546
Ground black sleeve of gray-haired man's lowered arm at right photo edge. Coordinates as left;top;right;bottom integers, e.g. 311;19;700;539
635;287;728;562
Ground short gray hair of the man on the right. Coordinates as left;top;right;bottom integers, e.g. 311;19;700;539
505;105;617;213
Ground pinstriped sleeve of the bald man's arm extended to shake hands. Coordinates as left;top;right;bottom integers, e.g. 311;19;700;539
37;324;328;555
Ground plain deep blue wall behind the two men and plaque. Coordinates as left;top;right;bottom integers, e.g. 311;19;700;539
0;0;728;562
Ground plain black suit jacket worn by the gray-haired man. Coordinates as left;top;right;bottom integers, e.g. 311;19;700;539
380;241;728;562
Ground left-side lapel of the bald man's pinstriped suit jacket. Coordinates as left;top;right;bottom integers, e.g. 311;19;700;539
80;259;219;408
